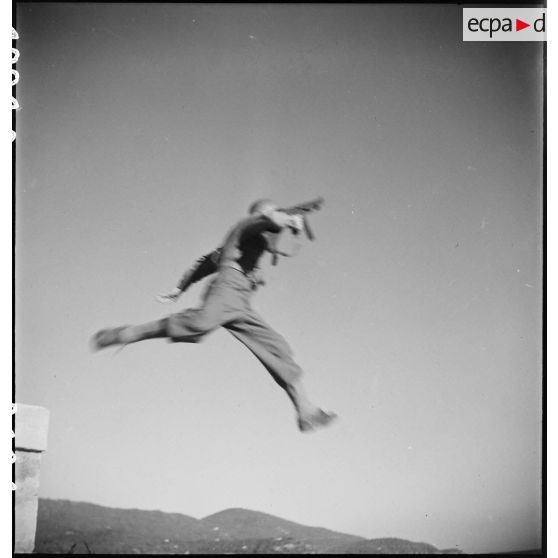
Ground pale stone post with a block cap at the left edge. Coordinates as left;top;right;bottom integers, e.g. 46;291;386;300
15;403;49;553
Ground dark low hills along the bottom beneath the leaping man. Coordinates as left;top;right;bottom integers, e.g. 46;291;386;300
35;498;464;554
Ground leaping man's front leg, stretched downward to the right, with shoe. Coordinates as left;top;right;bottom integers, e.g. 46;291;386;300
224;311;336;432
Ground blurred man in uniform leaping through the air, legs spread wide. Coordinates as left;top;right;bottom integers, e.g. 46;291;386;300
92;200;336;432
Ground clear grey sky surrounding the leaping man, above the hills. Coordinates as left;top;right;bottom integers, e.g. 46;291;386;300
15;3;543;552
